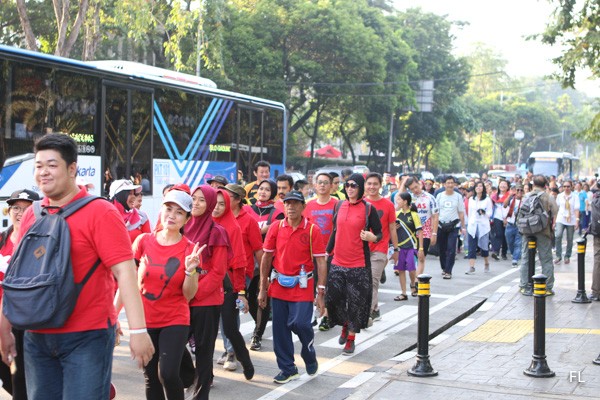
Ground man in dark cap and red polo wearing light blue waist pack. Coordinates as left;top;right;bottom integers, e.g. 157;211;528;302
258;190;327;384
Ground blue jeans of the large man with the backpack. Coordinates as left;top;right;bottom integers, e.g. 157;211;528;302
24;326;115;400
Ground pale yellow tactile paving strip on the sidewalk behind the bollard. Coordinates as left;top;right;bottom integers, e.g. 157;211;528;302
460;320;600;343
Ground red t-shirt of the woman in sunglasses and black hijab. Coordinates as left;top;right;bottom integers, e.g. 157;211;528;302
331;201;367;268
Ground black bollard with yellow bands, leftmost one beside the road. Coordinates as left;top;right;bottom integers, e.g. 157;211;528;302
408;274;437;376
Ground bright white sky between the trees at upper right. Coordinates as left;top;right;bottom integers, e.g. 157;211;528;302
394;0;600;97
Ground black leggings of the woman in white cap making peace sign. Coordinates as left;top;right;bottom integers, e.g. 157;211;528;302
144;325;189;400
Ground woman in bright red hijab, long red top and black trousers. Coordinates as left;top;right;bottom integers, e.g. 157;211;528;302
212;189;254;380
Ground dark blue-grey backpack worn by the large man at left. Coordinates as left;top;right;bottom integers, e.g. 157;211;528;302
2;196;101;329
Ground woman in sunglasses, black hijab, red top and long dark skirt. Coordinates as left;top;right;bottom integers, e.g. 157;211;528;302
325;174;382;355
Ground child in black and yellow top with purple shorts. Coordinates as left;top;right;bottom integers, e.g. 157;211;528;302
394;192;423;301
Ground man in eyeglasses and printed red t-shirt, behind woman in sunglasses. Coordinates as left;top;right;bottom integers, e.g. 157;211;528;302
304;172;339;331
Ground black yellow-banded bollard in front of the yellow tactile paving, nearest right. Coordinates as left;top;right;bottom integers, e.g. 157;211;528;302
523;274;556;378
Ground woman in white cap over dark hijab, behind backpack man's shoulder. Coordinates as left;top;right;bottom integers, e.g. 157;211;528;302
109;179;150;243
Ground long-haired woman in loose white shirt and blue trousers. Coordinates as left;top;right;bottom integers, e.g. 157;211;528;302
466;182;494;275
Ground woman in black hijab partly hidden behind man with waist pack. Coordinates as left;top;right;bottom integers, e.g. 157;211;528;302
248;179;284;351
